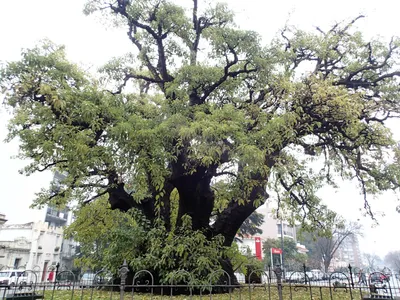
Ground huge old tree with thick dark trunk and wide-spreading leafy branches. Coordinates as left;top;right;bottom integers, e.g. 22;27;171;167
1;0;400;282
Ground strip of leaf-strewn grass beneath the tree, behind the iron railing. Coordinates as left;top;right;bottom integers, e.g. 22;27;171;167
39;286;362;300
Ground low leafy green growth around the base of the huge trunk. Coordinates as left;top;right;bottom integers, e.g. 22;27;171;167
66;198;231;284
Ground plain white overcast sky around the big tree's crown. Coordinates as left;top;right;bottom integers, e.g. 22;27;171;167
0;0;400;256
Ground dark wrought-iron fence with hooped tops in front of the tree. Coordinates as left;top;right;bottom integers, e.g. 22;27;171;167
0;263;400;300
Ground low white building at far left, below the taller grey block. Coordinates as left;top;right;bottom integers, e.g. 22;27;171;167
0;222;63;280
